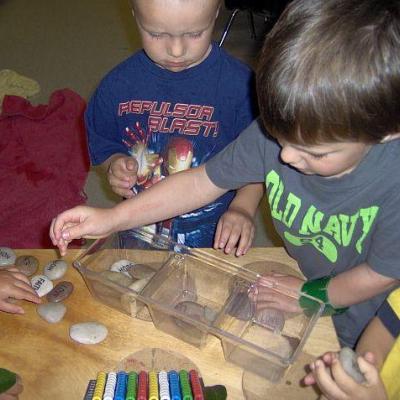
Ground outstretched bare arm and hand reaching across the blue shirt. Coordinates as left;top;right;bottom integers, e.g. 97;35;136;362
50;166;227;255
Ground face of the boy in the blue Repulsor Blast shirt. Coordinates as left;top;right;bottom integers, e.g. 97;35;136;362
134;0;218;72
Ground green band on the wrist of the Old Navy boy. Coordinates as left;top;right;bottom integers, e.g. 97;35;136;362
299;276;347;315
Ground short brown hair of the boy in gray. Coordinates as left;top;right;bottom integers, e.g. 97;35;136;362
257;0;400;144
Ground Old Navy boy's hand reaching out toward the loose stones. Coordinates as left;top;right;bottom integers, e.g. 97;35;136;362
49;206;116;256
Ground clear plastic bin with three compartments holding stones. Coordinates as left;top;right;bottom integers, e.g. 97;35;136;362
74;230;323;382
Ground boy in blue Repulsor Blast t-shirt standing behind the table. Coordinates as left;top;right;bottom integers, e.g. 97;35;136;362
86;0;263;255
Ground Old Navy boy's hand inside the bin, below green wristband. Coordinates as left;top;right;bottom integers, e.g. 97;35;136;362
249;273;304;313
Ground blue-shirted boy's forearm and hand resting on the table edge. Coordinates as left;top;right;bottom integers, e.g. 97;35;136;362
214;183;264;256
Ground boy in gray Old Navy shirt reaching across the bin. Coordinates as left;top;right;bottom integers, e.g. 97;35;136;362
50;0;400;347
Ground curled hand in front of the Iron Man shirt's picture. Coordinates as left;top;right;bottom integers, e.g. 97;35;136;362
107;156;138;199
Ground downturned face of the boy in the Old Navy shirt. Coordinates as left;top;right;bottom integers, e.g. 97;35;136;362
278;139;372;178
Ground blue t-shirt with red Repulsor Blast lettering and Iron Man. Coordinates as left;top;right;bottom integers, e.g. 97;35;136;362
85;44;257;247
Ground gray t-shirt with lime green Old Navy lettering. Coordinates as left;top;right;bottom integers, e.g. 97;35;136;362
206;121;400;346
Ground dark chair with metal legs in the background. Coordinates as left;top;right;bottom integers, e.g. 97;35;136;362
218;0;290;47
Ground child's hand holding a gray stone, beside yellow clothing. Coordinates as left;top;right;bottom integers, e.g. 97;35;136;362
304;352;387;400
